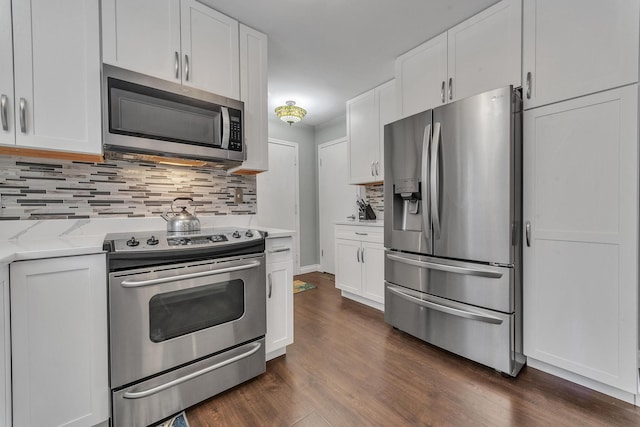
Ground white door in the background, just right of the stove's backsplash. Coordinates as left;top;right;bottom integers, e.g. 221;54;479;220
256;139;300;274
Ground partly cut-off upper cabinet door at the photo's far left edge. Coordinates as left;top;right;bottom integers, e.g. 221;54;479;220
0;0;16;145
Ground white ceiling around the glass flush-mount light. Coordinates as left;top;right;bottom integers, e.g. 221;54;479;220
199;0;498;126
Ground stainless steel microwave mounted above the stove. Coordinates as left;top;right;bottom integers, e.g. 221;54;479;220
102;64;245;162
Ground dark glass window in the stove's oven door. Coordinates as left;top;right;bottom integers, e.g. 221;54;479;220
149;279;245;343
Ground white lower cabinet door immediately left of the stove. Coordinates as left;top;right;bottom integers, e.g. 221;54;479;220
10;255;109;426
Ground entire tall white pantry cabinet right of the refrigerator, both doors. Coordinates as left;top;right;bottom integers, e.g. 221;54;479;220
522;0;640;404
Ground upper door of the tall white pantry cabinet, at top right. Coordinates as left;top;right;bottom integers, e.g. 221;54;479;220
522;0;640;108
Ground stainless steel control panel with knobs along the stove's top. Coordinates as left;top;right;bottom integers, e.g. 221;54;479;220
105;228;264;252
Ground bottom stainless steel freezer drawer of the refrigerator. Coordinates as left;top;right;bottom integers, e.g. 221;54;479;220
384;282;522;376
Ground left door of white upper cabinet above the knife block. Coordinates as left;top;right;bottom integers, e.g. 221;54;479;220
347;90;381;184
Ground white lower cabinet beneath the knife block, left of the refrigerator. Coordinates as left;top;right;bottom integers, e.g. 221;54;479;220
335;224;384;310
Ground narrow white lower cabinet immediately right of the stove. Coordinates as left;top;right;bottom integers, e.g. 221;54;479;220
265;237;293;360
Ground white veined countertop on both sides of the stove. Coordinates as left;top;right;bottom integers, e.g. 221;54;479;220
0;216;295;265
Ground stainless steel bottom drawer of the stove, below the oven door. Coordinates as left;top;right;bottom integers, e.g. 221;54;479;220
112;339;266;427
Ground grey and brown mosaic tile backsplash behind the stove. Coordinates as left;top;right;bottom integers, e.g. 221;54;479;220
0;156;256;220
